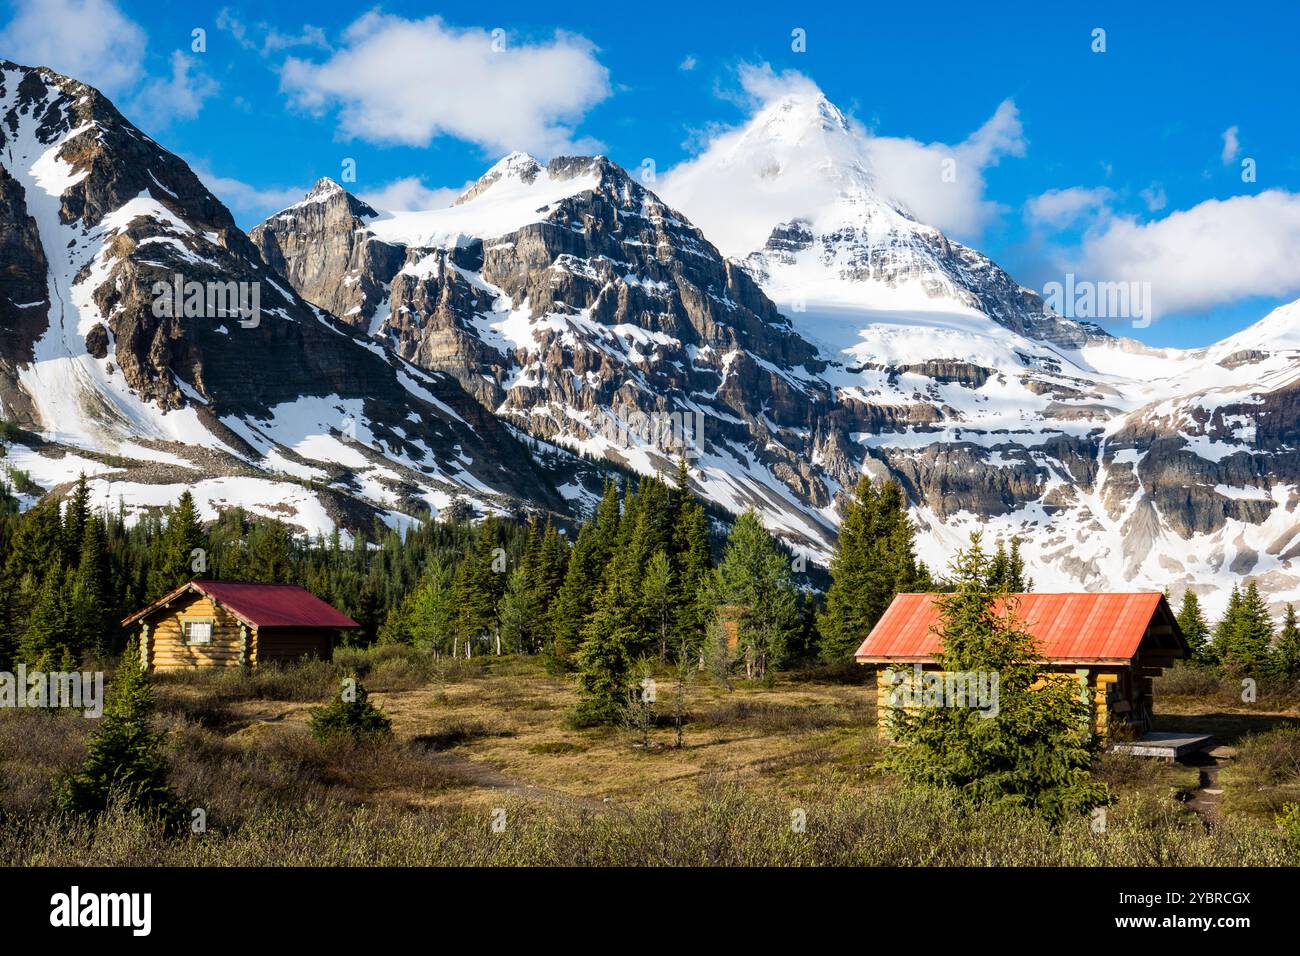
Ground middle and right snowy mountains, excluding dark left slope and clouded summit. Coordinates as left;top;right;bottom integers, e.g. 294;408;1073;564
245;140;1300;606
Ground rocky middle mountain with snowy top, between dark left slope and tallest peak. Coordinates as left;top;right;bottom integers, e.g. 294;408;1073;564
254;153;852;548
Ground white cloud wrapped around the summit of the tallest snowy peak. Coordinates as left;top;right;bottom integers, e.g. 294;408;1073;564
655;64;1024;256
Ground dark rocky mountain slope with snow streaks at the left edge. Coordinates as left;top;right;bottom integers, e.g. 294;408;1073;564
0;62;567;531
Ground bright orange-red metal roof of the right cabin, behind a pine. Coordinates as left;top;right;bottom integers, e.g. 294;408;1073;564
855;591;1164;663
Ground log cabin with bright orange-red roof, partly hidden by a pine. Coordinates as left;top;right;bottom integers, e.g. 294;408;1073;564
855;592;1190;737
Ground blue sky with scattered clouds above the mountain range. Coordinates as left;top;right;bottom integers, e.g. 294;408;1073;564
0;0;1300;346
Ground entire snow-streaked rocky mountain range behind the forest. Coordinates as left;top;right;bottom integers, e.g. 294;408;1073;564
0;64;1300;613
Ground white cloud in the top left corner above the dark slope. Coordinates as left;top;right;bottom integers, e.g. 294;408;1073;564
0;0;147;94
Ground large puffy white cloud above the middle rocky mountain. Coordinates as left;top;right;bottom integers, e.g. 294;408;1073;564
281;10;610;156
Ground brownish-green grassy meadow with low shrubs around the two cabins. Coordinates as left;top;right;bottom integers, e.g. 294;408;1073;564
0;658;1300;866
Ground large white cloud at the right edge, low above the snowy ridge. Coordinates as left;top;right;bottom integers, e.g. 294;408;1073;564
1078;190;1300;315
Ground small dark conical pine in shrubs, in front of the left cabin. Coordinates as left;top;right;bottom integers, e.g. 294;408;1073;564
57;643;177;818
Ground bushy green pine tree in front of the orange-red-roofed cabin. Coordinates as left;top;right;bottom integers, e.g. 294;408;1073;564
888;535;1109;822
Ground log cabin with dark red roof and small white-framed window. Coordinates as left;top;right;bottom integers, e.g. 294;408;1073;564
122;580;360;671
